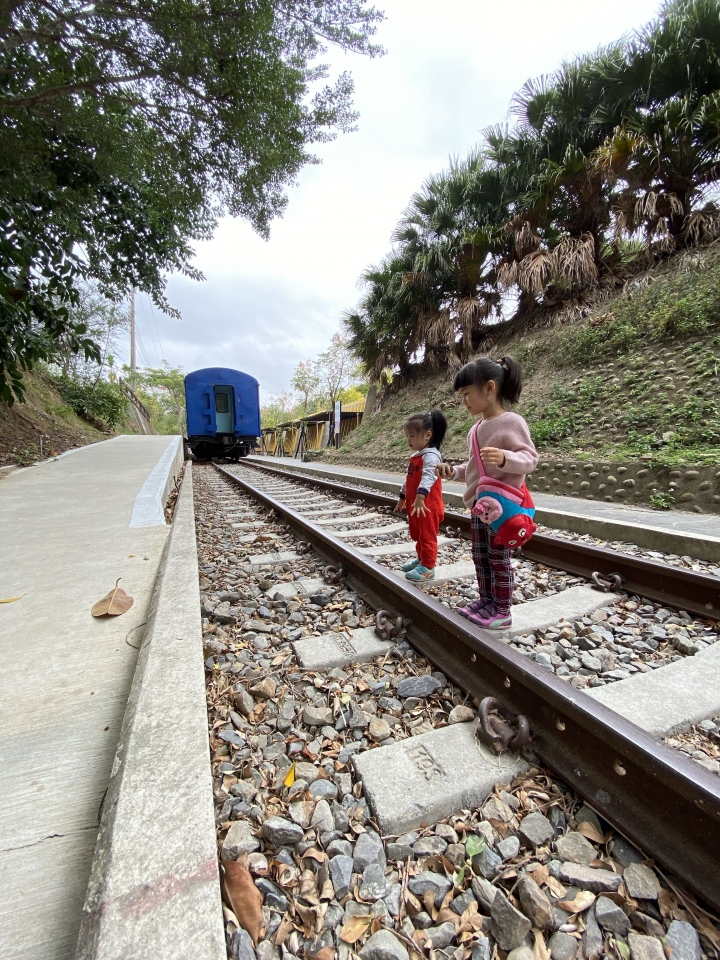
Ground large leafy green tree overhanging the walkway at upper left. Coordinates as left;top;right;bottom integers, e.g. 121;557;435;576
0;0;381;403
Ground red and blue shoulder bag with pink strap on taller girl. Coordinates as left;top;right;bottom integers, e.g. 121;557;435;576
472;422;537;550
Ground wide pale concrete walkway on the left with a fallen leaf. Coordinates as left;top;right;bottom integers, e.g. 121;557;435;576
0;436;182;960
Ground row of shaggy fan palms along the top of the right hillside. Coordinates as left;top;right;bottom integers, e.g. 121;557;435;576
344;0;720;378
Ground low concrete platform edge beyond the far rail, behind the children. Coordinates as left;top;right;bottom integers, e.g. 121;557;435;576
248;456;720;562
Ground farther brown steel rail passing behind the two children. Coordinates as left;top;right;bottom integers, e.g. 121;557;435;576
238;463;720;618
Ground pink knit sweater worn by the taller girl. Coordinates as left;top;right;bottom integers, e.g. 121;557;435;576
453;410;539;507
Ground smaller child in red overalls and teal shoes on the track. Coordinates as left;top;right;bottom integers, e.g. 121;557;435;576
395;410;447;580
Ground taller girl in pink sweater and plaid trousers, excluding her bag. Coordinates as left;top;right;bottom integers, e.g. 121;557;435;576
437;357;538;630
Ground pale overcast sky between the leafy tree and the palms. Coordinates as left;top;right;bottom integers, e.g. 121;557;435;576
124;0;658;397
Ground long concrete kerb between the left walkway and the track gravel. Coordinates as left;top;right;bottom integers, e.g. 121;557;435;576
76;464;226;960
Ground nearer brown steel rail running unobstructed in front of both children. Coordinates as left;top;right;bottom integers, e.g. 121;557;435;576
215;465;720;909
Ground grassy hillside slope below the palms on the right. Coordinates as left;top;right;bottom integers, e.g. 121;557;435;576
323;246;720;469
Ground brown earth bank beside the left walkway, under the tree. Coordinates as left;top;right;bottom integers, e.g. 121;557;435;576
0;369;124;466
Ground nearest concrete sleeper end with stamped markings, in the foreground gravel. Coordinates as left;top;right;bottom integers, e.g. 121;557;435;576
353;723;527;836
